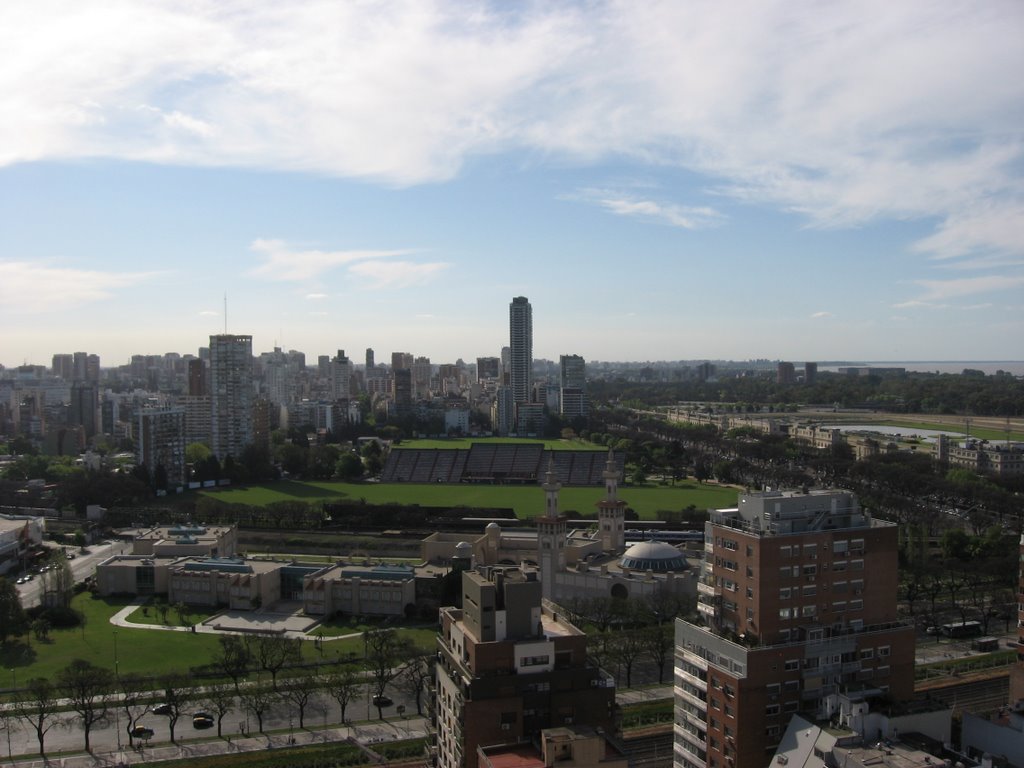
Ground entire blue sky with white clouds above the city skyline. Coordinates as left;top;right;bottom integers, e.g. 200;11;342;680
0;0;1024;367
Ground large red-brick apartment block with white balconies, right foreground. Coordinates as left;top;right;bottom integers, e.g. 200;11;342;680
675;490;914;768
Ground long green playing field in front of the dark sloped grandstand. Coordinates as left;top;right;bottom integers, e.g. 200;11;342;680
201;480;739;520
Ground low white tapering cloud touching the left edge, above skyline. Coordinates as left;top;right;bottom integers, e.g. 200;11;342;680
0;260;158;314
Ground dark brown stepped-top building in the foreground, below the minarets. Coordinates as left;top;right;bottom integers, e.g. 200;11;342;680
434;568;616;768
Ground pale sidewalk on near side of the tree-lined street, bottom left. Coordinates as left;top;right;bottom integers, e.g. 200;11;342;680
5;717;427;768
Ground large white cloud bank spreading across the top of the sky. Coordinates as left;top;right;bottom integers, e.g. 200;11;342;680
0;0;1024;270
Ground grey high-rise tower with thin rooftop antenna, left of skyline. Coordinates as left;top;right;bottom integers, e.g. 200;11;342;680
210;334;254;462
